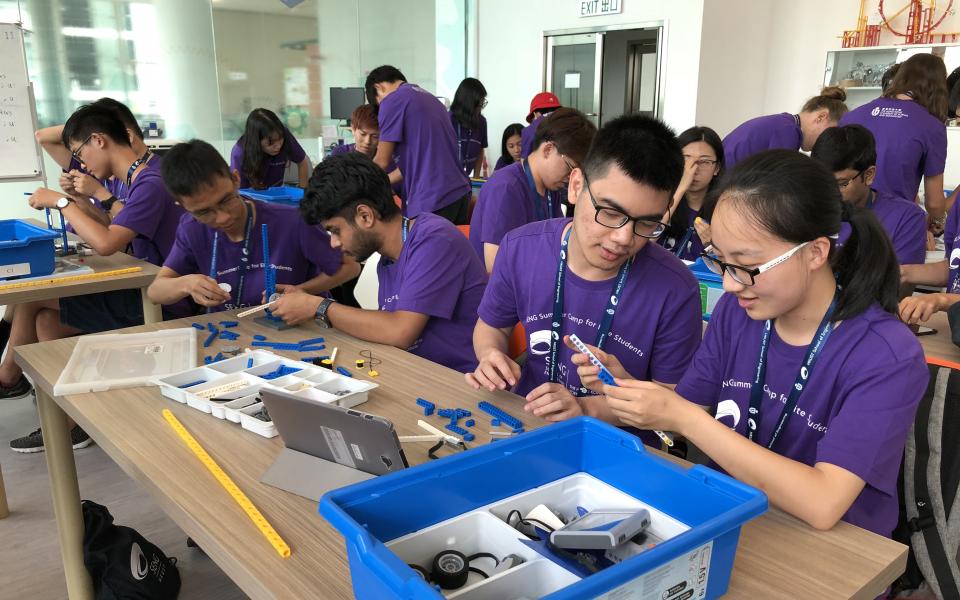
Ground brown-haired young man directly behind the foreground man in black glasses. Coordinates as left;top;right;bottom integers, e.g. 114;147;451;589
470;108;597;272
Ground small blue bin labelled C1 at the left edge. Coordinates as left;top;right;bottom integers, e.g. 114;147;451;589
0;219;60;279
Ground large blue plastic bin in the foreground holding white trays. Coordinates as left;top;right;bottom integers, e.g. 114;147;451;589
320;417;767;600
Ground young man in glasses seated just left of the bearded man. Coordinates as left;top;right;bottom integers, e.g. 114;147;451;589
147;140;360;310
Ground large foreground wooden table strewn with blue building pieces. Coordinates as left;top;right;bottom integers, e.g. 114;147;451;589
16;313;907;600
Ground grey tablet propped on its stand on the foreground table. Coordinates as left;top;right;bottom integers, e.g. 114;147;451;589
260;389;408;500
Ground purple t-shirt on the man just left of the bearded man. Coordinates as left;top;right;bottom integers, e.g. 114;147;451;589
163;200;341;310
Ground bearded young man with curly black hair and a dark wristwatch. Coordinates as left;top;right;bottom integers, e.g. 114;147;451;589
271;152;487;373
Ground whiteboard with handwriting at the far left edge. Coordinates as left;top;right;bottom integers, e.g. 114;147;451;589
0;23;43;179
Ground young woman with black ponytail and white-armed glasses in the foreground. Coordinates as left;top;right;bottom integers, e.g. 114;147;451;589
574;150;928;537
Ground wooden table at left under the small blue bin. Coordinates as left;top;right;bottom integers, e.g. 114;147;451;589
0;219;163;323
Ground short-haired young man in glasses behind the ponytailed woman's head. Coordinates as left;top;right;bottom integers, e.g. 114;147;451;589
810;125;927;266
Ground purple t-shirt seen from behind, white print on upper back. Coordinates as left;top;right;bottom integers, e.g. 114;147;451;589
840;98;947;200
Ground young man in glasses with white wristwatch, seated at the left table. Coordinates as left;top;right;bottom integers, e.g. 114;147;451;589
10;105;190;453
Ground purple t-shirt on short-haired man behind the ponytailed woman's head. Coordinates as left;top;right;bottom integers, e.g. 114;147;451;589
837;192;927;265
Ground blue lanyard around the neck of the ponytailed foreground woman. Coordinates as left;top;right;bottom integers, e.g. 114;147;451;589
747;296;837;450
